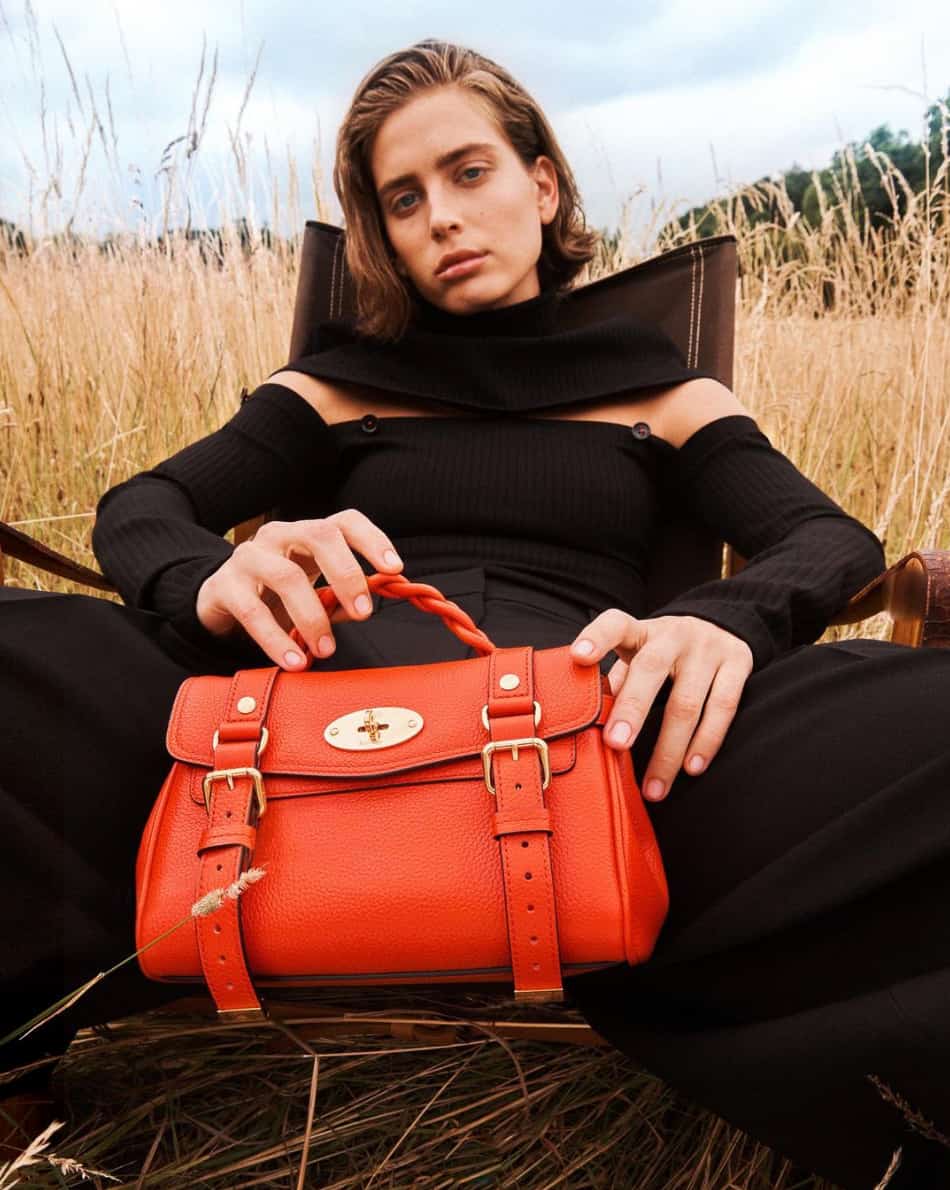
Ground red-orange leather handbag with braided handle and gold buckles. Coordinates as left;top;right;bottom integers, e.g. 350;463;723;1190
136;572;669;1020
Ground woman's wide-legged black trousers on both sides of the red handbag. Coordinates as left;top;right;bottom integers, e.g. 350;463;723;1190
0;566;950;1190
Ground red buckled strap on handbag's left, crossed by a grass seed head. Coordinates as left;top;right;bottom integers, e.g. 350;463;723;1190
195;665;280;1019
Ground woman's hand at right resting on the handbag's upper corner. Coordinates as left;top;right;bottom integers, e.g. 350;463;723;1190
571;607;752;801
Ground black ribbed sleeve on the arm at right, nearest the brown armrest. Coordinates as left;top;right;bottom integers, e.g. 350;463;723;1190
648;414;886;670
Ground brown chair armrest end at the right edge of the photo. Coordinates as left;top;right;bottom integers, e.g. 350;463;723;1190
831;550;950;649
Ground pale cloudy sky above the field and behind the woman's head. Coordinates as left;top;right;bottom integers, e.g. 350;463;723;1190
0;0;950;246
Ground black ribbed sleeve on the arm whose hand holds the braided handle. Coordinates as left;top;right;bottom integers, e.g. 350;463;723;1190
92;382;336;666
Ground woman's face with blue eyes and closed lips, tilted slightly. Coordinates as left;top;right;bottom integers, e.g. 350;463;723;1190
370;87;566;314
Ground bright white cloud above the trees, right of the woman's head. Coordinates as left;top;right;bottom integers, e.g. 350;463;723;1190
560;5;950;234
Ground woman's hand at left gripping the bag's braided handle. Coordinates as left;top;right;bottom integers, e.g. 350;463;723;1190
195;508;402;670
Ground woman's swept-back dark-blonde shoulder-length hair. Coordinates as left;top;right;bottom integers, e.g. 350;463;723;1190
333;38;601;340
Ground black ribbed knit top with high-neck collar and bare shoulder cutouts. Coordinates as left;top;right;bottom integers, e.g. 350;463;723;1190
92;279;885;671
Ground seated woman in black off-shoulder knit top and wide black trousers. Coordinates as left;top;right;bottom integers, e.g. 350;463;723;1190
0;42;950;1190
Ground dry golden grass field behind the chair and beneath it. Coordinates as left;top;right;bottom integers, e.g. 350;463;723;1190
0;53;950;1190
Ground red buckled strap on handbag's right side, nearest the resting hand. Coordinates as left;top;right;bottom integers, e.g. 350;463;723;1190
487;645;564;1001
